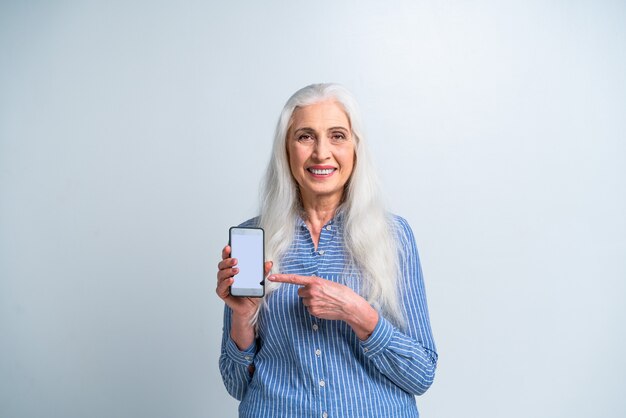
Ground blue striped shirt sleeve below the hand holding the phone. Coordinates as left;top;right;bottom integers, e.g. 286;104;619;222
219;305;257;401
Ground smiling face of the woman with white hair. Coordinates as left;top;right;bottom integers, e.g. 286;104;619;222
287;100;354;205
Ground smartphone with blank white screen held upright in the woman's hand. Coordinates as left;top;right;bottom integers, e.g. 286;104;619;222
228;226;265;298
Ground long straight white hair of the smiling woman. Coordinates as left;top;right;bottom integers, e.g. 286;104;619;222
260;84;405;326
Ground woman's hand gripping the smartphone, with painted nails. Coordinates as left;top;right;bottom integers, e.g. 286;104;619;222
215;245;272;318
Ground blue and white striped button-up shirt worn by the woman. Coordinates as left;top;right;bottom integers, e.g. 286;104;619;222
219;214;437;418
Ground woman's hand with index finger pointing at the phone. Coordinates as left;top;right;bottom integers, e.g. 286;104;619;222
269;274;378;340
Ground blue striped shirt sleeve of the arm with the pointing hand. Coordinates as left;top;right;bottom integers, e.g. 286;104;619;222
361;217;437;395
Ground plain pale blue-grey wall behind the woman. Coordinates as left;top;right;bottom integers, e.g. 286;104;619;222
0;0;626;418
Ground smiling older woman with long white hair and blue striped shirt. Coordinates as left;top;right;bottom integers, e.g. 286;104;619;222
216;84;437;418
